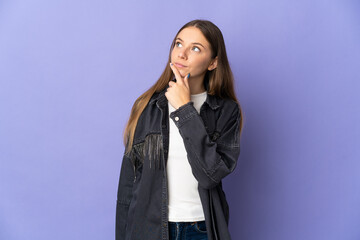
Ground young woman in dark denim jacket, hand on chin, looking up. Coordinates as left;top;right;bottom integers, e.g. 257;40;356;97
116;20;242;240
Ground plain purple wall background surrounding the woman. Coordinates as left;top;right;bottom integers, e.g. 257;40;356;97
0;0;360;240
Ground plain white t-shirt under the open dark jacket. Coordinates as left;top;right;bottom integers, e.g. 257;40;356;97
166;91;207;222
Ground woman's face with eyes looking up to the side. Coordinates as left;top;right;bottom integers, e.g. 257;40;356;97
171;27;216;80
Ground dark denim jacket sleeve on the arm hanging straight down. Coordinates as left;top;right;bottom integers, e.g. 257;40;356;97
115;154;134;240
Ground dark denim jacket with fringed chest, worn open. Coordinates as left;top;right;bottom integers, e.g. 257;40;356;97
115;86;241;240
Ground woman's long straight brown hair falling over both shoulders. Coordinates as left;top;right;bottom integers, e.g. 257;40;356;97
123;19;243;154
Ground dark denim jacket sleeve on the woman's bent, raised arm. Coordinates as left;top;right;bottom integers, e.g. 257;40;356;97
170;101;241;189
